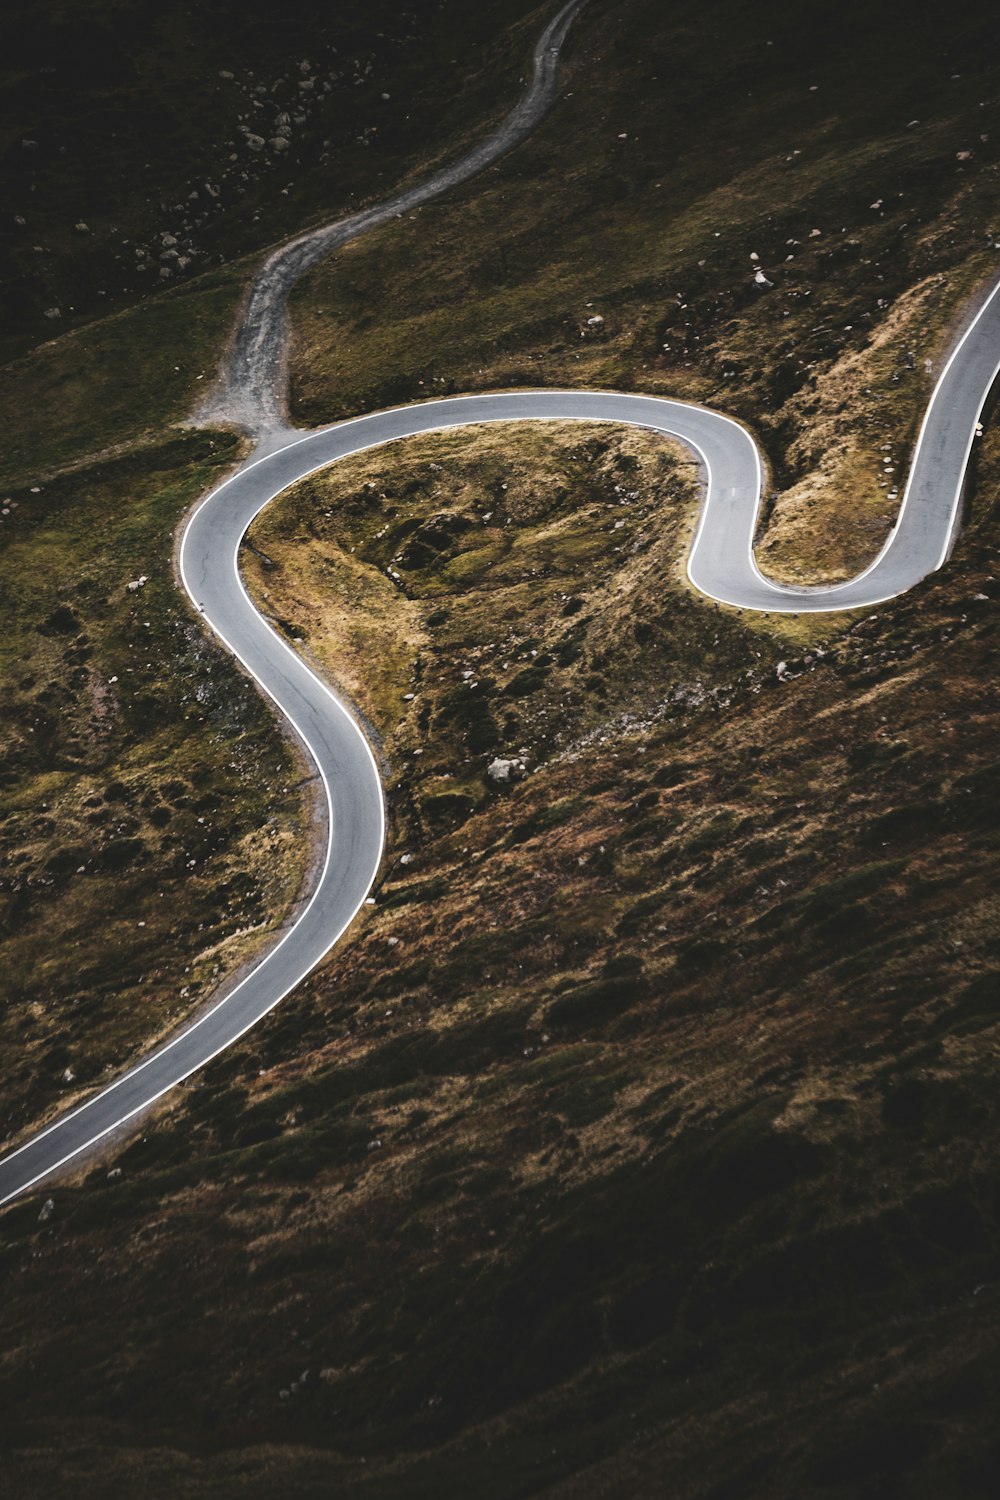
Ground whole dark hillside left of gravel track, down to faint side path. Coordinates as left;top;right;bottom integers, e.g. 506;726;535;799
0;0;554;483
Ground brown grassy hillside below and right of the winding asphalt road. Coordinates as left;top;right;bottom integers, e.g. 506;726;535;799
3;429;1000;1497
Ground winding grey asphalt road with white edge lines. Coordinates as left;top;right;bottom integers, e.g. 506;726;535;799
0;5;1000;1205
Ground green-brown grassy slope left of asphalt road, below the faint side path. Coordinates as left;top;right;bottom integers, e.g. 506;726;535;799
0;435;306;1136
